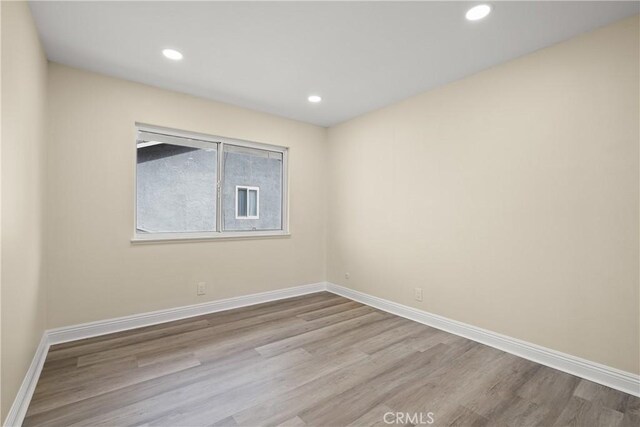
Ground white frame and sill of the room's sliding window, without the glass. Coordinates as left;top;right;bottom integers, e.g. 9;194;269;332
131;123;290;243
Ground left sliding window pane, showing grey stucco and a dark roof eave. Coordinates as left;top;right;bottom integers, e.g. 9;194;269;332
136;140;217;233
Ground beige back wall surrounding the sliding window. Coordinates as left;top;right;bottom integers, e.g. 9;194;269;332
47;63;326;327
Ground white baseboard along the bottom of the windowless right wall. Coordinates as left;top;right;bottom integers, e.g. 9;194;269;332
327;283;640;397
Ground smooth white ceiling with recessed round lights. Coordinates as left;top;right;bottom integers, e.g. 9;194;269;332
30;1;640;126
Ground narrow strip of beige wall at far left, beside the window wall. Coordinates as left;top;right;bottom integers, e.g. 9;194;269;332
0;2;47;419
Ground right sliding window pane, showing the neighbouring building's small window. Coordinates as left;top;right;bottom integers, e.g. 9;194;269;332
222;144;283;231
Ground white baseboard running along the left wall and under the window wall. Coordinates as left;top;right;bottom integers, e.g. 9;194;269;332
3;282;326;427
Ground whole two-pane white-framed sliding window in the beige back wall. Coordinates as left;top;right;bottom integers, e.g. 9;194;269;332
134;125;288;240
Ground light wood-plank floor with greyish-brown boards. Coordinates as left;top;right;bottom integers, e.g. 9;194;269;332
24;292;640;427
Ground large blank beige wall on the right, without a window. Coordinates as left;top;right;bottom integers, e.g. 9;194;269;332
327;16;640;373
